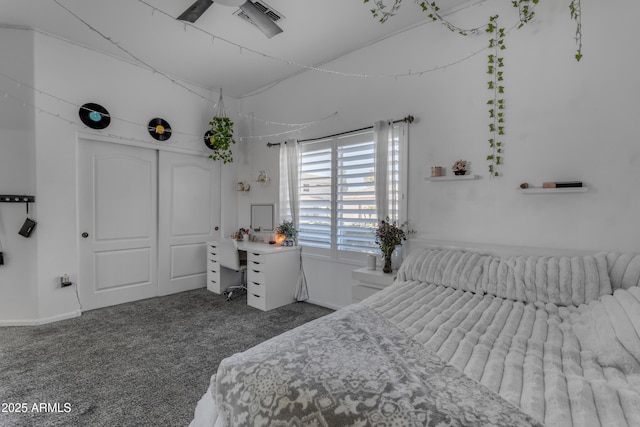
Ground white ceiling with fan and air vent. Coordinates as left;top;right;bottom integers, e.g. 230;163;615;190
0;0;469;98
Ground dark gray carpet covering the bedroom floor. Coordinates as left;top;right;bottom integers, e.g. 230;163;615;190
0;289;332;427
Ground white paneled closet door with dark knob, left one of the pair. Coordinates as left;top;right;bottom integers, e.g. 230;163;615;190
78;140;158;310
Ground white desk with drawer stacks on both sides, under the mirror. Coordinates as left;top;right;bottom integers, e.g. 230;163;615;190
207;241;300;311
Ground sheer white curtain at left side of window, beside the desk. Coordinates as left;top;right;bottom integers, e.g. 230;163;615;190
280;139;309;301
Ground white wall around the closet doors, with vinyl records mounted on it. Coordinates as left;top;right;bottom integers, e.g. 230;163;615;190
0;29;230;324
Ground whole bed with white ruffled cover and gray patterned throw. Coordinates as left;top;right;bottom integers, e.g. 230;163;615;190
192;244;640;427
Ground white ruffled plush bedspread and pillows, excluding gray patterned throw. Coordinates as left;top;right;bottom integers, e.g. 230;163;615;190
362;250;640;427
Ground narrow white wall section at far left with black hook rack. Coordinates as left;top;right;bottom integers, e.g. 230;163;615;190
0;29;38;320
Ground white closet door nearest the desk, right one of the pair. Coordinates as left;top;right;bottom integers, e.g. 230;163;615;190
158;151;220;295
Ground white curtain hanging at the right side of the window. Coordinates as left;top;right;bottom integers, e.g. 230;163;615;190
373;120;393;221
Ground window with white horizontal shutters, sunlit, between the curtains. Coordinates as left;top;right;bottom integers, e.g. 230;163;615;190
298;123;406;255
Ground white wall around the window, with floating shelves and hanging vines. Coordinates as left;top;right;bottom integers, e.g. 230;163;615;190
242;0;640;306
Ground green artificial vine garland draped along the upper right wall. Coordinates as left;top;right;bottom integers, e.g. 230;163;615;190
363;0;582;177
